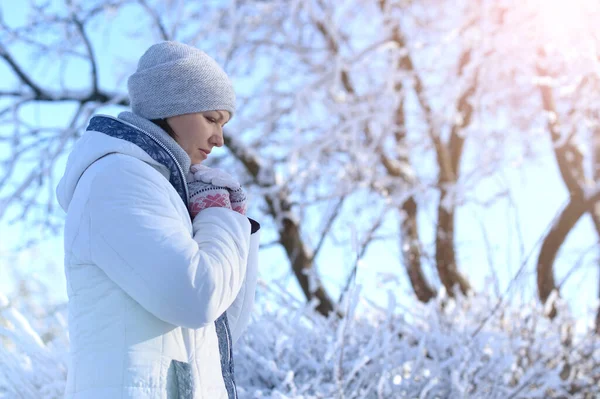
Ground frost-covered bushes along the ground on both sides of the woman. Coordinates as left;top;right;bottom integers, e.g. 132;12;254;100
0;288;600;399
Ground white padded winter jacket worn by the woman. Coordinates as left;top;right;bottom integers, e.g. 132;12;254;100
57;117;259;399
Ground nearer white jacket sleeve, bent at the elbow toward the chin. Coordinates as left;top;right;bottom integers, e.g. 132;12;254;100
88;156;250;329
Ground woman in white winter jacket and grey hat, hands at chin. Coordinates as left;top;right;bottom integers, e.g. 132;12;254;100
57;42;260;399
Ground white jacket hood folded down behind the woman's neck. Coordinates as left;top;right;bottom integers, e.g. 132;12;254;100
56;116;169;212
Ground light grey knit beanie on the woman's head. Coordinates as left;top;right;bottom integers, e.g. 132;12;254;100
127;42;235;119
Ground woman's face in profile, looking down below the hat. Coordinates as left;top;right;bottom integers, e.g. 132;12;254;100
167;111;230;165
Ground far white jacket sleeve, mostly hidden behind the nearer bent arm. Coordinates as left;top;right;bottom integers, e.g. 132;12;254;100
227;219;260;344
